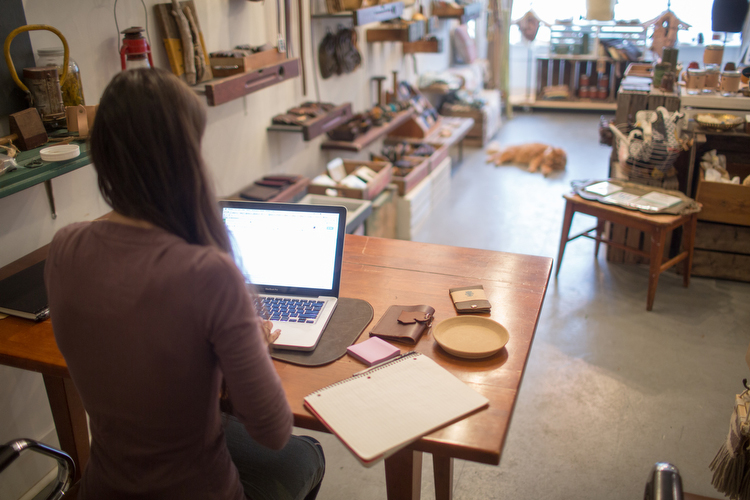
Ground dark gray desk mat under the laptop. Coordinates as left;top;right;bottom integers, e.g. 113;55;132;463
271;297;373;366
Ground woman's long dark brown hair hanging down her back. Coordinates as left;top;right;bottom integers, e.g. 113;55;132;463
90;68;231;253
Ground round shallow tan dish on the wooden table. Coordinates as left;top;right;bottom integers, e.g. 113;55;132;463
432;316;510;359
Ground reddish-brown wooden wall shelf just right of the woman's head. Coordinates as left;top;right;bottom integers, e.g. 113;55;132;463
204;59;299;106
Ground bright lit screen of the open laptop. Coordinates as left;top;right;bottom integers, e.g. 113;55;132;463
221;201;346;296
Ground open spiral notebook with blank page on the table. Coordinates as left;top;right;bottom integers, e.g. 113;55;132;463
305;352;489;467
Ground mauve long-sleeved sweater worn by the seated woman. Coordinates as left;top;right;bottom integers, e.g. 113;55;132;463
45;221;292;500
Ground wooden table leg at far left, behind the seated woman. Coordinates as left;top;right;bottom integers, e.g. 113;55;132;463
44;375;90;481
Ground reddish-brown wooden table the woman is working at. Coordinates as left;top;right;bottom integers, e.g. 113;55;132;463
0;235;552;500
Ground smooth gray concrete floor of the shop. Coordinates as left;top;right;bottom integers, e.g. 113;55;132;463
299;112;750;500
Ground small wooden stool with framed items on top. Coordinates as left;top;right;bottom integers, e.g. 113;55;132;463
555;193;698;311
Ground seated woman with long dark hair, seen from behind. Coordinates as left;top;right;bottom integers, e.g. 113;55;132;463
45;69;325;500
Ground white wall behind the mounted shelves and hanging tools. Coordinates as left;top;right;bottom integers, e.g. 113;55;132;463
0;0;464;499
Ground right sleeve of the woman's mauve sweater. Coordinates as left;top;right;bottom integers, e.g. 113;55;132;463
203;253;293;449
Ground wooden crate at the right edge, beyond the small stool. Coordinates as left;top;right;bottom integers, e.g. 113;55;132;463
695;163;750;226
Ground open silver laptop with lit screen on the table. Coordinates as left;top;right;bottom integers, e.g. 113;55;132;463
219;200;346;351
